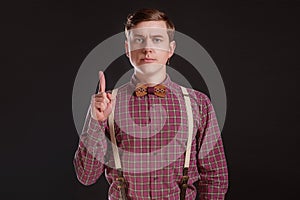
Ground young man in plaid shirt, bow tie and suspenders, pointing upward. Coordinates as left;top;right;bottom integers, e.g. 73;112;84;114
74;9;228;200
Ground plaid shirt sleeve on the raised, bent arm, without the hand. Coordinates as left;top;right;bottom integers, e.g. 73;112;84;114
73;105;107;185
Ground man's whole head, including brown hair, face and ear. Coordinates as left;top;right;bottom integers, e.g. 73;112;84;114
125;9;175;75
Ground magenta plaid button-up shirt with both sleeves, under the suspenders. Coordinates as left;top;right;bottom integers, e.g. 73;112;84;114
74;75;228;200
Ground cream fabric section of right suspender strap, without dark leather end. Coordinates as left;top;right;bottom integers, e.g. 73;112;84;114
181;86;194;168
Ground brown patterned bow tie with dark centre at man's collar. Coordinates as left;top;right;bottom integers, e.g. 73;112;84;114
135;84;166;97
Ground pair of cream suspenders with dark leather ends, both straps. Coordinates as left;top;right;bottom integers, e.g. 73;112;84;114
108;86;194;200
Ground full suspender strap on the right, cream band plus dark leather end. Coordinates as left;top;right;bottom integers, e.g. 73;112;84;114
180;86;194;200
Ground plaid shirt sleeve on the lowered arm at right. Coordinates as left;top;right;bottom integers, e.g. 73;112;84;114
197;96;228;200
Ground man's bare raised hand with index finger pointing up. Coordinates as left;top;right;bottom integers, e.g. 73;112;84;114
91;71;112;121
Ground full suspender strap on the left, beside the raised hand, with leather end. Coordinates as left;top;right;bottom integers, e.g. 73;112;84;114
108;89;127;200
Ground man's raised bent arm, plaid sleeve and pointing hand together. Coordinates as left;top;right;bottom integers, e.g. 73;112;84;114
73;71;112;185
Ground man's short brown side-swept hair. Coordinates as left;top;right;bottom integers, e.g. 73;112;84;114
125;8;175;41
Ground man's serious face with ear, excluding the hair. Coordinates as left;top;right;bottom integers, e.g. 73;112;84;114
125;21;175;73
